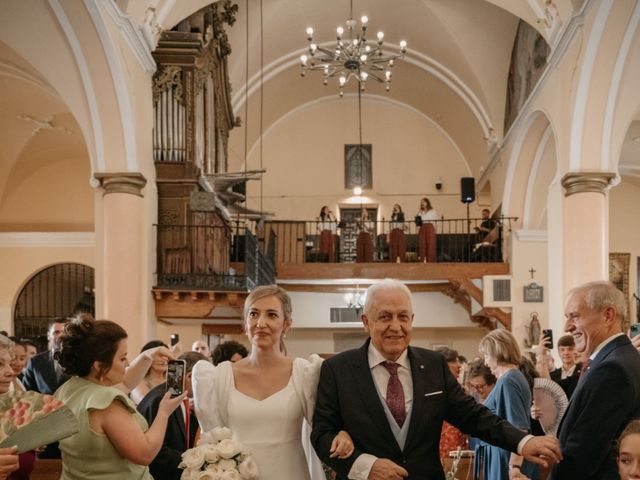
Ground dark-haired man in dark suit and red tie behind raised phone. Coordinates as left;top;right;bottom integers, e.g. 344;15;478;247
138;352;209;480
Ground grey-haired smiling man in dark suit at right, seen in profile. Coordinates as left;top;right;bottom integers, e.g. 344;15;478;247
551;282;640;480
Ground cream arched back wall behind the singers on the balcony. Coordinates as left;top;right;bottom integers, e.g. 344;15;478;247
242;99;479;223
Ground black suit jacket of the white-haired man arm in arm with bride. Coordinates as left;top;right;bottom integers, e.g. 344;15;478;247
311;340;525;480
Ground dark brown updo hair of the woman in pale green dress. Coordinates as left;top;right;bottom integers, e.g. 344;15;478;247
54;315;127;379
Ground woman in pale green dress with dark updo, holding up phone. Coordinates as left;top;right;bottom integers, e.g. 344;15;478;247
55;317;186;480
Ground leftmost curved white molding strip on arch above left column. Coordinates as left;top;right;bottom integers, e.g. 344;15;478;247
48;0;105;172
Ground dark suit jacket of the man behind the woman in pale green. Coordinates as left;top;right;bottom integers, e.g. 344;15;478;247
138;383;198;480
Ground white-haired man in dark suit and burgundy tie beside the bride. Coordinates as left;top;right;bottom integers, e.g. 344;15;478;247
311;280;560;480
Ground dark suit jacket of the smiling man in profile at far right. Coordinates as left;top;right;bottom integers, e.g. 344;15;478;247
550;336;640;480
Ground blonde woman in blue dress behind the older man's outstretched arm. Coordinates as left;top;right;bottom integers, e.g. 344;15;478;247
474;329;538;480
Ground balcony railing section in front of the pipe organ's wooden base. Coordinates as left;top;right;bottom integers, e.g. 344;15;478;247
156;225;275;291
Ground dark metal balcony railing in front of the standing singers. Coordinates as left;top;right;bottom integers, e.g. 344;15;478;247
255;217;517;263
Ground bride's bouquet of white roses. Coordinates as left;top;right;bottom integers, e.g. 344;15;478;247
179;427;258;480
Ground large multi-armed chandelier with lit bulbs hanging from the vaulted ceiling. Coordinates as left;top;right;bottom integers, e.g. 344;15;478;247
300;0;407;97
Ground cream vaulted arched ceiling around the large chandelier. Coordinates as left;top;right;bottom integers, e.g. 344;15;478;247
158;0;577;176
